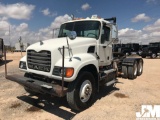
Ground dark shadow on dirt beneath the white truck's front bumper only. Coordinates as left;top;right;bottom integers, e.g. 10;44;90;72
17;95;77;120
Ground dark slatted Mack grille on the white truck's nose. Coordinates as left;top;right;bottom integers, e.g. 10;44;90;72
27;50;51;72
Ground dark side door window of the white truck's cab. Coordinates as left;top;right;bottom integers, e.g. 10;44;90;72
101;26;110;44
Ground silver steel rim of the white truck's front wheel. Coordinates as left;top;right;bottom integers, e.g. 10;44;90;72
79;80;92;103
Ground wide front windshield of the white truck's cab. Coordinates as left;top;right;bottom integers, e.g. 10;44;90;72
58;21;100;39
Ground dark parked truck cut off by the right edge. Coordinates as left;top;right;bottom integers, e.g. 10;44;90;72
141;42;160;58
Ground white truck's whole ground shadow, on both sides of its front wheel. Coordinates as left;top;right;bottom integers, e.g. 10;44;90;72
17;81;119;120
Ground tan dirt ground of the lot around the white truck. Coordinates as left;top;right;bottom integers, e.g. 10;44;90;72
0;53;160;120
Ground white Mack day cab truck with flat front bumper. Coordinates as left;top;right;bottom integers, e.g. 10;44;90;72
6;16;143;111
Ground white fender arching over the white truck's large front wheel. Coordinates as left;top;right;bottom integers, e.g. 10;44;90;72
52;53;99;82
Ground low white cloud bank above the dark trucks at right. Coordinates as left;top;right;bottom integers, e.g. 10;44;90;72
119;19;160;44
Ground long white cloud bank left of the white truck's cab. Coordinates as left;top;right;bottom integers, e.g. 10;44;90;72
0;14;69;45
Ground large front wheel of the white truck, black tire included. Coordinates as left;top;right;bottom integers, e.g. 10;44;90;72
67;71;96;111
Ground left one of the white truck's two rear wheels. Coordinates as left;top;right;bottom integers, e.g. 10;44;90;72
128;61;137;79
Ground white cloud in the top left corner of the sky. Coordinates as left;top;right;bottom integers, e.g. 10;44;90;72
0;3;35;20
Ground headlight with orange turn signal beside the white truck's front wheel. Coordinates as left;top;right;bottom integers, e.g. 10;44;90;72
53;66;74;78
